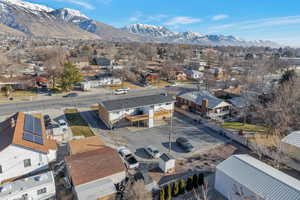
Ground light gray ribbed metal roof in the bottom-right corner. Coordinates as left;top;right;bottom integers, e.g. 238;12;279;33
217;155;300;200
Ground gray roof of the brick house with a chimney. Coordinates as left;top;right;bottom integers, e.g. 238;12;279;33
179;91;223;109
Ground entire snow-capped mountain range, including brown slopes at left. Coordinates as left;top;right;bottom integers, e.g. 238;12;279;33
0;0;277;46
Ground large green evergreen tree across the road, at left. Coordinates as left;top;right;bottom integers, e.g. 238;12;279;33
61;63;83;91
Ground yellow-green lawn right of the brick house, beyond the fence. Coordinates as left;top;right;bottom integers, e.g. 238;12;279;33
220;122;266;132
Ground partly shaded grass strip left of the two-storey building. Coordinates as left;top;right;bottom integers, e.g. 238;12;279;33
64;109;94;137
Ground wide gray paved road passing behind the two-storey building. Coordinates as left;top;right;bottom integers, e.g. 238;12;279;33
0;89;165;115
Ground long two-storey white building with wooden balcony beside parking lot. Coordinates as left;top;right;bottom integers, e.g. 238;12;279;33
99;94;175;128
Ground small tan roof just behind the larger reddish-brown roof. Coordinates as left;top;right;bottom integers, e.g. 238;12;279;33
68;136;105;155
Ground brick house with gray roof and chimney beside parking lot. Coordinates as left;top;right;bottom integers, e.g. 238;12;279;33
176;91;231;119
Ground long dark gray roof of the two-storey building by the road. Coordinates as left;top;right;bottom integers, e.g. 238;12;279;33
100;94;175;111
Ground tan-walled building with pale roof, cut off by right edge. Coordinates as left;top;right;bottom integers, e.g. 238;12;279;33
280;131;300;161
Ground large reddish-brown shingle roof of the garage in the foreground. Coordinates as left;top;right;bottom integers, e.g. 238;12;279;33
65;147;126;186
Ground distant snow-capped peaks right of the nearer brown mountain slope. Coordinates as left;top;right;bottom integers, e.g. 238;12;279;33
122;24;277;46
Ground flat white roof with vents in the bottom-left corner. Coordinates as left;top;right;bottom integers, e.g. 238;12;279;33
0;171;55;199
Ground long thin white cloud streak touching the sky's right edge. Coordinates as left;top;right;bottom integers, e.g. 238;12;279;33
209;16;300;31
